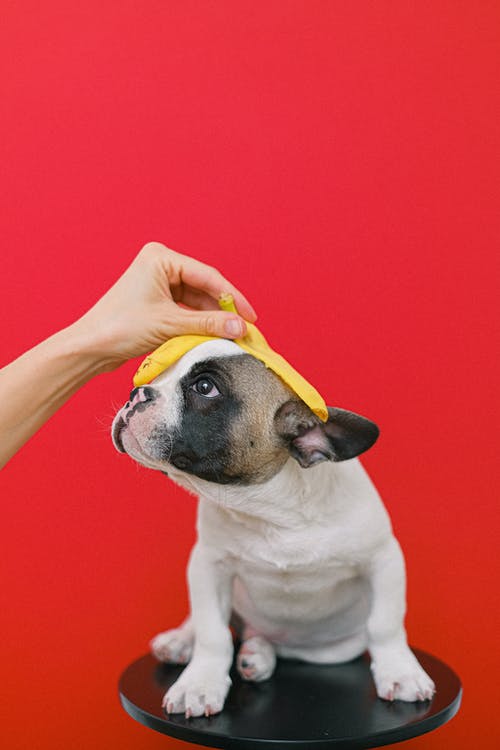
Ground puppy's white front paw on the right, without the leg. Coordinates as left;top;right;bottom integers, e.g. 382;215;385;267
372;652;436;702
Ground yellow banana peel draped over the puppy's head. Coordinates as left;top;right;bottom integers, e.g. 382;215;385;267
134;294;328;422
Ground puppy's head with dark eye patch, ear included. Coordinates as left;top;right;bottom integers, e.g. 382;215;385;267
112;339;378;485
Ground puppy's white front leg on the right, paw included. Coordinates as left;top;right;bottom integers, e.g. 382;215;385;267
368;537;435;701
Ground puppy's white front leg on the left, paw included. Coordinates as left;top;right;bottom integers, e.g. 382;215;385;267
163;544;233;717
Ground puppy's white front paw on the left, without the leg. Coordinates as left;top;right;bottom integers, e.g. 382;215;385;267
162;667;231;719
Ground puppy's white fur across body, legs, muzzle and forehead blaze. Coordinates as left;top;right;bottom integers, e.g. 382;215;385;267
113;341;434;716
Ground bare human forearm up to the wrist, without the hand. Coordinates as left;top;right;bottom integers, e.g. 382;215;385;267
0;323;116;468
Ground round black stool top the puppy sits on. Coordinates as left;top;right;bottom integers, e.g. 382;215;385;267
119;649;462;750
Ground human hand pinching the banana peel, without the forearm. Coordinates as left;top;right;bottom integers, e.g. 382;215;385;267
74;242;256;369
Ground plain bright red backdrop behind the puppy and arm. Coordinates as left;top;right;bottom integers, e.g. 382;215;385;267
0;0;500;750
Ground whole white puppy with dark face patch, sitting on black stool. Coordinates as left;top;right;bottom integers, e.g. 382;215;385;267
113;339;434;717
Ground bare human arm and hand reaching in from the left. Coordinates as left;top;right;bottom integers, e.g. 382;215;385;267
0;242;255;468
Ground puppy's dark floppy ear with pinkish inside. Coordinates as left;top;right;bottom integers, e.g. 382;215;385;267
274;400;379;468
